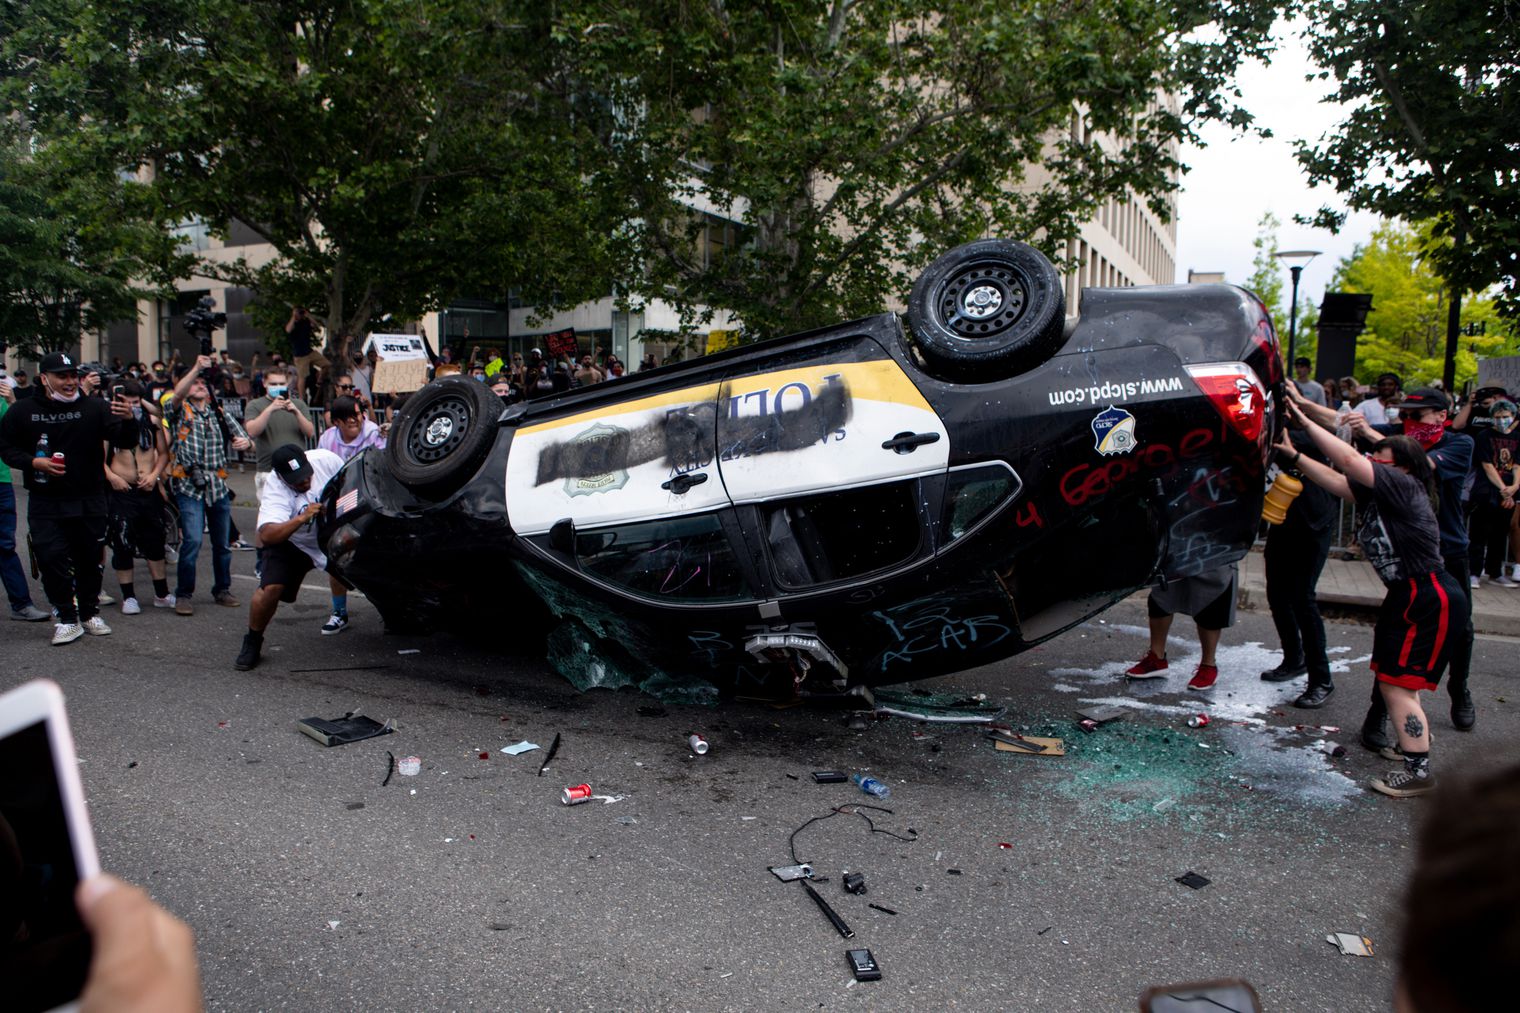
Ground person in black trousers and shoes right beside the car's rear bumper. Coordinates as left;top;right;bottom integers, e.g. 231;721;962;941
1262;430;1338;709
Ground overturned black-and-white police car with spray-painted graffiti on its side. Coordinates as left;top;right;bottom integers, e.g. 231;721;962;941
321;240;1283;692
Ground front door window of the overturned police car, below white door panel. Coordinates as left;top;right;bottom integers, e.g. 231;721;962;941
575;514;754;601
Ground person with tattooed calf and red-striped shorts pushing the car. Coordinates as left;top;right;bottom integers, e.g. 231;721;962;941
1277;400;1468;799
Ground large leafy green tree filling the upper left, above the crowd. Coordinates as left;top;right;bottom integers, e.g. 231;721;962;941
0;0;613;343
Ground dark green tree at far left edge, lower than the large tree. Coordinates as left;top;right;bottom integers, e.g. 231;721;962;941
0;135;184;362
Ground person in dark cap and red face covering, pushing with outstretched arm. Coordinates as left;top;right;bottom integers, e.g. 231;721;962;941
1289;386;1477;730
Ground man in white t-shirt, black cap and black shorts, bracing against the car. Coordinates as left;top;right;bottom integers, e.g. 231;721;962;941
233;443;344;672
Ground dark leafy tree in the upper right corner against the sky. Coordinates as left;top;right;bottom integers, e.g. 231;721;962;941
1298;0;1520;382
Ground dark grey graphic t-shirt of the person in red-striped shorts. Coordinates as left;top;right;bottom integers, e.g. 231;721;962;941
1351;462;1446;584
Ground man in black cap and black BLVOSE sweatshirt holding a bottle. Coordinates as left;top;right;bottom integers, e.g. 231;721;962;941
0;351;132;645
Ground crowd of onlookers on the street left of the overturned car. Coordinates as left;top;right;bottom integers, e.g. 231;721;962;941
0;316;657;669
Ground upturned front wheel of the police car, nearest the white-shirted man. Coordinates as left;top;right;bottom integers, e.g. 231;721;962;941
386;376;502;496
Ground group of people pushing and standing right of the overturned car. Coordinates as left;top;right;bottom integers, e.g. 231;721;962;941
1126;366;1520;797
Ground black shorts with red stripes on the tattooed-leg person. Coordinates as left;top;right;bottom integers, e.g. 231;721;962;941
1373;570;1467;689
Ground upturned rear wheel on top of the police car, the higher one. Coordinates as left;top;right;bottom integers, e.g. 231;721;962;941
907;239;1066;382
